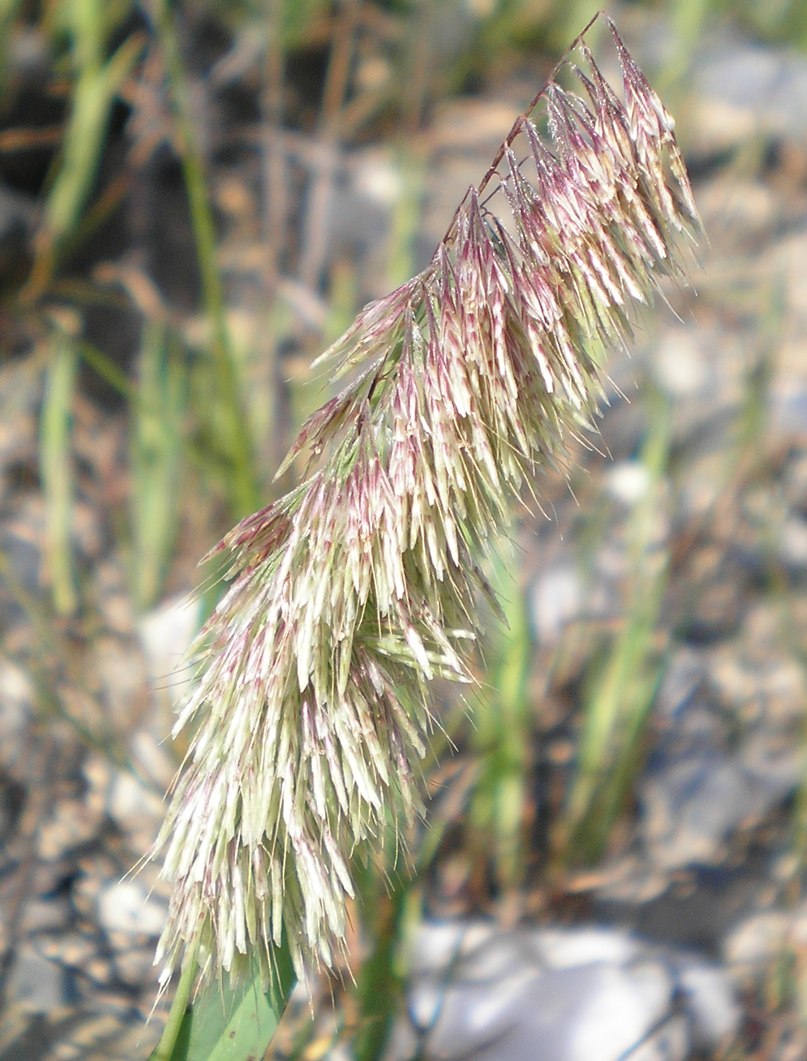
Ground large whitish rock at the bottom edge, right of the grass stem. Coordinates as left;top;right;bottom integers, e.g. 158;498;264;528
389;922;738;1061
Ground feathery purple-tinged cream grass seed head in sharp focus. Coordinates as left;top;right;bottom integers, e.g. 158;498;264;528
149;12;699;981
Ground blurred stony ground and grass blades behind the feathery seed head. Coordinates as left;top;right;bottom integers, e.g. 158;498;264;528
0;0;807;1061
